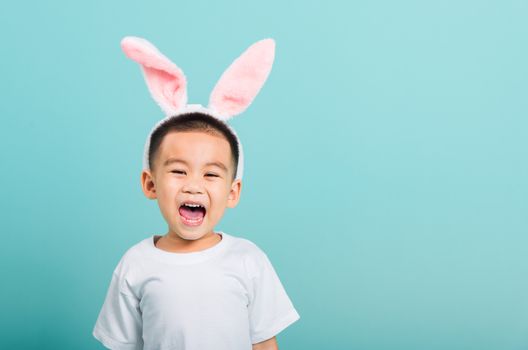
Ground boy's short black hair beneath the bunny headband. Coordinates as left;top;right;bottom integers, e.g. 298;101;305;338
149;112;239;180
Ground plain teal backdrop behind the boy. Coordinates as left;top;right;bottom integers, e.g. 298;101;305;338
0;0;528;350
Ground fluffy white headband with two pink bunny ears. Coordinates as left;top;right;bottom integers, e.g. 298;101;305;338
121;36;275;179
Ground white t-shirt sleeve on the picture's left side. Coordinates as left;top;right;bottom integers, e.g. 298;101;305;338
92;262;143;350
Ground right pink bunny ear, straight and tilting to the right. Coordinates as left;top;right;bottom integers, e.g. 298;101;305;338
209;39;275;120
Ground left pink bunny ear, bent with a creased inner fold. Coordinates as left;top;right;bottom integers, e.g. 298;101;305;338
121;36;187;115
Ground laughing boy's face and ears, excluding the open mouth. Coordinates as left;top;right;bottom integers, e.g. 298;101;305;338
141;131;242;240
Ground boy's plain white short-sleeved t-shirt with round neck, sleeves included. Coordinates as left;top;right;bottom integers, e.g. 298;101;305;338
93;231;300;350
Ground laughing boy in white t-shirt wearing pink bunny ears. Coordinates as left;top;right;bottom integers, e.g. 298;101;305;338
93;37;300;350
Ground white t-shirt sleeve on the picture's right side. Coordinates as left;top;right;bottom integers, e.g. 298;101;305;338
248;249;300;344
